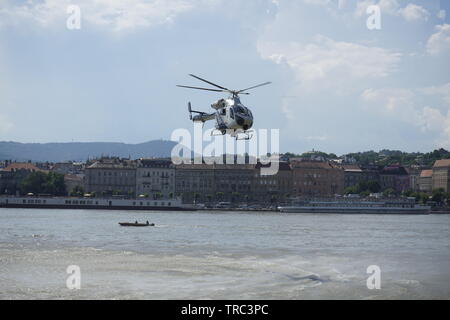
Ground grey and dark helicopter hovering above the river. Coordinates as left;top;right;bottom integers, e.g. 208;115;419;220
177;74;271;140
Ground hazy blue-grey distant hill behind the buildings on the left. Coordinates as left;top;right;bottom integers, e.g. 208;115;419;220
0;140;176;162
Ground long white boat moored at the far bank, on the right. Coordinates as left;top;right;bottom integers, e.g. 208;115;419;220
278;200;431;214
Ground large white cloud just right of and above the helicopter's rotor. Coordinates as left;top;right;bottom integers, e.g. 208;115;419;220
258;36;401;89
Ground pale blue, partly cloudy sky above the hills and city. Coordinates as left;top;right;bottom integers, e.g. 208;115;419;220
0;0;450;155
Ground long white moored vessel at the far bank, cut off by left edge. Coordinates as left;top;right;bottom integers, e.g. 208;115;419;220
0;197;193;211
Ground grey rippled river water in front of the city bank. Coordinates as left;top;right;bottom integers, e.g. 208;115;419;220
0;209;450;299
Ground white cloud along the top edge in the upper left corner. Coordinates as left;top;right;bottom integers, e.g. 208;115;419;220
0;0;218;32
